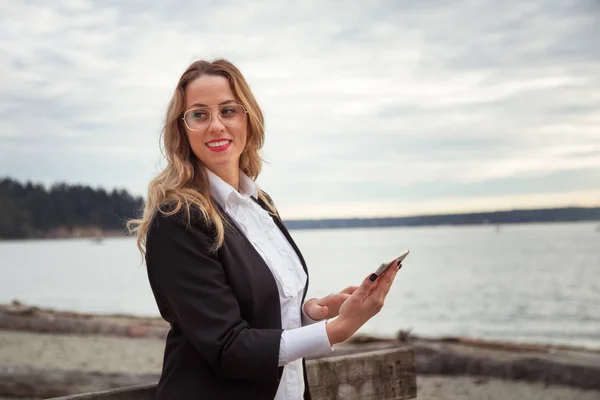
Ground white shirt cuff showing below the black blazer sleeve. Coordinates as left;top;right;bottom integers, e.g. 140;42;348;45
279;321;333;367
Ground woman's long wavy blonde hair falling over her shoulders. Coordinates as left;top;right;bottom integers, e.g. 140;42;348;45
127;59;277;257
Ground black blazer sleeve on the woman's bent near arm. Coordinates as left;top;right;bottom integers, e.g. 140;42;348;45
146;212;282;381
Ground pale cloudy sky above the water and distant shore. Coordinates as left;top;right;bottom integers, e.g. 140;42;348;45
0;0;600;218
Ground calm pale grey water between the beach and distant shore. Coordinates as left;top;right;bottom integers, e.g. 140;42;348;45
0;223;600;349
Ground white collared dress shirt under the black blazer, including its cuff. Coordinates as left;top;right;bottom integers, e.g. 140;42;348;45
206;169;333;400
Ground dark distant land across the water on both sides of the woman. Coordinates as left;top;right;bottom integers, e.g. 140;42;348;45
0;178;600;239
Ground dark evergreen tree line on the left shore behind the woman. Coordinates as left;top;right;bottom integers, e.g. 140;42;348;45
0;178;143;239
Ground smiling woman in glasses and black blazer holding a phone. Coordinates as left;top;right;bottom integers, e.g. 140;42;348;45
129;60;404;400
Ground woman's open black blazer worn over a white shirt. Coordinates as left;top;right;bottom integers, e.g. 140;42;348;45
146;193;310;400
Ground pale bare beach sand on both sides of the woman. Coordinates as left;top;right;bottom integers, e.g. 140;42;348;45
0;331;600;400
